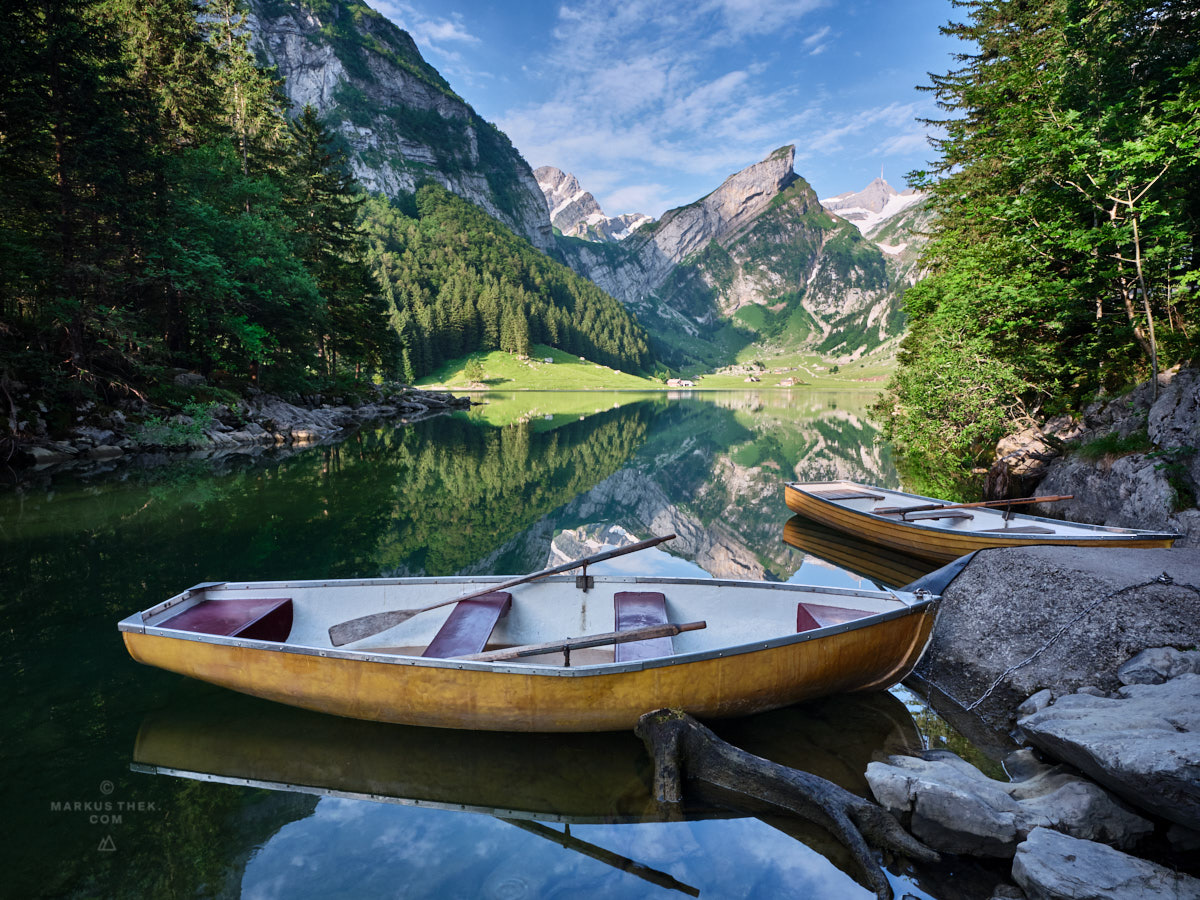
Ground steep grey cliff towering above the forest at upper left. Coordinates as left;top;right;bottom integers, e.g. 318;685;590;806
248;0;554;252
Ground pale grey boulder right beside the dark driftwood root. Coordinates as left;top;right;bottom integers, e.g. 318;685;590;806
866;750;1153;858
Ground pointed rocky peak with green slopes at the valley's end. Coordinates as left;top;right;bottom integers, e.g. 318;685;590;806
560;146;900;364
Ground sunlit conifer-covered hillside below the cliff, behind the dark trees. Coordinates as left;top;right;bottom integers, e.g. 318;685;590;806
362;184;653;380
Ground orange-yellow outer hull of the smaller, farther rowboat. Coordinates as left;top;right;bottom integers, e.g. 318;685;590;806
784;484;1176;563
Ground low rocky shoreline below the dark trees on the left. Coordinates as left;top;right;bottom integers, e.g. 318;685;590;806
8;385;472;470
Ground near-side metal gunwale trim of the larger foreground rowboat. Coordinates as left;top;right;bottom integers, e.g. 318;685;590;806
133;595;935;678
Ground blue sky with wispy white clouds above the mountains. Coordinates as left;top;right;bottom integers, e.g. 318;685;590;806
368;0;961;216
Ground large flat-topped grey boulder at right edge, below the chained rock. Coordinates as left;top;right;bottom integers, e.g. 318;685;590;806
1020;673;1200;830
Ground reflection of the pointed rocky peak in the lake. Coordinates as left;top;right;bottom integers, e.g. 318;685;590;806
473;392;896;580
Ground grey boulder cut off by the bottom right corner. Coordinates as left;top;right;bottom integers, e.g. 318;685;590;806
1013;828;1200;900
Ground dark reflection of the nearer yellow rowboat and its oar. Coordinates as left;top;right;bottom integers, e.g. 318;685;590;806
132;691;922;895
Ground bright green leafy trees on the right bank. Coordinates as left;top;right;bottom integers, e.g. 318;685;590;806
878;0;1200;490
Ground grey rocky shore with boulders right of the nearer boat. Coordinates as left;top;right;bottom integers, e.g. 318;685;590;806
892;547;1200;900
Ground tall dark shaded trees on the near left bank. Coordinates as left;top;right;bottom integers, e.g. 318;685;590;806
0;0;395;417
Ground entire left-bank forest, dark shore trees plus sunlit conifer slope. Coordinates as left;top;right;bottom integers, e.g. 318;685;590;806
0;0;652;434
